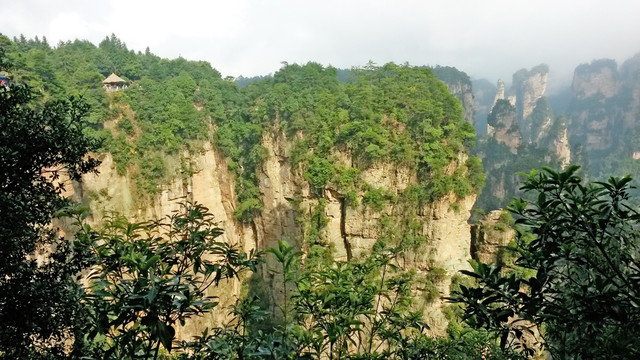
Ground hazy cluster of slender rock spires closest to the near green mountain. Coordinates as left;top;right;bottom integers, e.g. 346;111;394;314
478;65;571;210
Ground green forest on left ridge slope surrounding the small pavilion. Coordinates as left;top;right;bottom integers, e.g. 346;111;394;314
0;35;255;205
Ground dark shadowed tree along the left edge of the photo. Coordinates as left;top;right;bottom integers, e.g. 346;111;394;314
0;53;98;359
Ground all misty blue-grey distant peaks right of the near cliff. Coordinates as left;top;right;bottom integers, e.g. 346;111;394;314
448;51;640;214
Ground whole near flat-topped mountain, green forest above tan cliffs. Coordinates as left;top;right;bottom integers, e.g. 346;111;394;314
0;36;500;354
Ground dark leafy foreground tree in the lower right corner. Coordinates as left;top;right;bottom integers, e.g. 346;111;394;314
455;166;640;359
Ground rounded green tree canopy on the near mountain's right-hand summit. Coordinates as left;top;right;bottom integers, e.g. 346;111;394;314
242;63;481;207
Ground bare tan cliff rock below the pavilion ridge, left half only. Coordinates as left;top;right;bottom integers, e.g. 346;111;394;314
66;144;255;337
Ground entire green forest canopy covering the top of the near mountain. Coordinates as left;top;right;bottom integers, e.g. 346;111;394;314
2;35;480;222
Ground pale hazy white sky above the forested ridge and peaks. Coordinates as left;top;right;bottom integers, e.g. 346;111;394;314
0;0;640;90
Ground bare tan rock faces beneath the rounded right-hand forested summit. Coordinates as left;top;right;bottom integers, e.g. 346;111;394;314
253;129;475;335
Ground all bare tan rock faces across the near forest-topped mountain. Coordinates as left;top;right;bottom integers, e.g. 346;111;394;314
74;127;475;337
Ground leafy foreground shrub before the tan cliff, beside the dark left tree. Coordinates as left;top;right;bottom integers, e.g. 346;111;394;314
67;202;258;359
